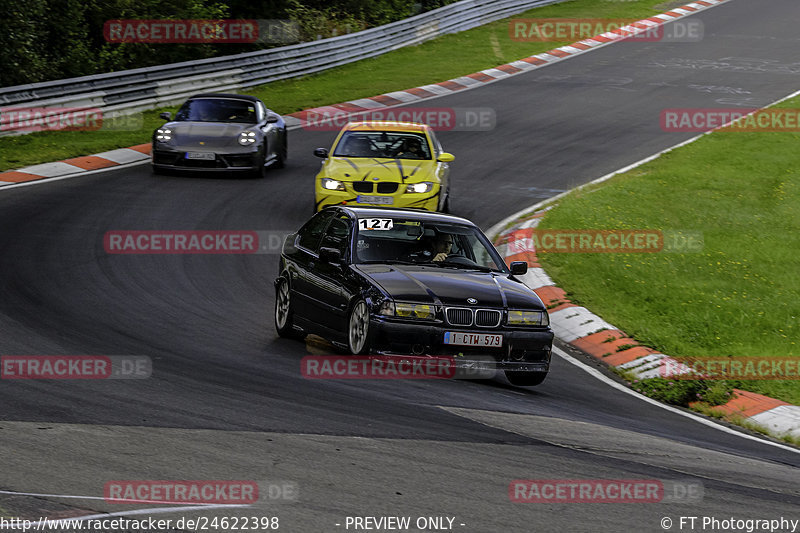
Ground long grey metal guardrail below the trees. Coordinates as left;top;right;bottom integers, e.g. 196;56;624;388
0;0;564;114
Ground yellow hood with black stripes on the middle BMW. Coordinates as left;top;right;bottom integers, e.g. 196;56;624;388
323;157;436;183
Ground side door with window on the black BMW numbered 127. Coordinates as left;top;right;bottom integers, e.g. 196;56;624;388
308;214;353;333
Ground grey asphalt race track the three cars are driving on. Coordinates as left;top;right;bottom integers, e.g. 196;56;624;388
0;0;800;533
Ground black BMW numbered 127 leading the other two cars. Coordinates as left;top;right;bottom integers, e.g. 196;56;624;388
275;206;553;386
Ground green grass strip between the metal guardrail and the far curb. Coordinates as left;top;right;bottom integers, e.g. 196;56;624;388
0;0;672;170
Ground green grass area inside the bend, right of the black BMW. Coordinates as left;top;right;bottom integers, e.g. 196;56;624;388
539;98;800;405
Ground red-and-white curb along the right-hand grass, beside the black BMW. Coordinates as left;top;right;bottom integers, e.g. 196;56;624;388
489;206;800;438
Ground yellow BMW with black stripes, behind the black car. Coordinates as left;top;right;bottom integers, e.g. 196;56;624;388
314;122;455;213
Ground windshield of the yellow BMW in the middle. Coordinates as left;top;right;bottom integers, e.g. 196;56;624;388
333;131;431;159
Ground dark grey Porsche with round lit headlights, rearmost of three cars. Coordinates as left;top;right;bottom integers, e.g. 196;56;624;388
152;93;288;176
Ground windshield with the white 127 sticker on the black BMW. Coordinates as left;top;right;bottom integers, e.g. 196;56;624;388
353;217;508;272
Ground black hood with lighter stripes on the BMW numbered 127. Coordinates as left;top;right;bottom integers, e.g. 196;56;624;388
355;264;545;310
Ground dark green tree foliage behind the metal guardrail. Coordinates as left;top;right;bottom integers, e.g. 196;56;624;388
0;0;454;87
